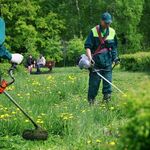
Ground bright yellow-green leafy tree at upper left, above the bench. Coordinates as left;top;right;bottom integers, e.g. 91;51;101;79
2;0;65;61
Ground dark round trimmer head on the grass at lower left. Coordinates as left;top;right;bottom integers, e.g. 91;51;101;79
22;128;48;141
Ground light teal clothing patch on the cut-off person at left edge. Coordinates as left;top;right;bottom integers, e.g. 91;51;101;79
0;17;5;45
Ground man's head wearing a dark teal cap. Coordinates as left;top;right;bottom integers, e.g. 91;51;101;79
101;12;112;29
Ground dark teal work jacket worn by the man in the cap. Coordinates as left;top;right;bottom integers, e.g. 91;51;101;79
84;26;118;67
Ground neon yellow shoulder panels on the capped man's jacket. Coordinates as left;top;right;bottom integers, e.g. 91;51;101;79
92;27;116;40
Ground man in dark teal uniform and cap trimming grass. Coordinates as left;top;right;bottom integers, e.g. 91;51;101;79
85;12;119;105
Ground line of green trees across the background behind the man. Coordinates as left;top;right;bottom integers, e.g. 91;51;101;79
0;0;150;65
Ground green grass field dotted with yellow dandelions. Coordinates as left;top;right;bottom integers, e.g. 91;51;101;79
0;67;149;150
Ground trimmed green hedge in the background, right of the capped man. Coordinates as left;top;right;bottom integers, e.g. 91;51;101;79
121;52;150;71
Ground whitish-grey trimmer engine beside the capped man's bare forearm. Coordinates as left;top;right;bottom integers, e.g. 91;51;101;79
78;54;91;69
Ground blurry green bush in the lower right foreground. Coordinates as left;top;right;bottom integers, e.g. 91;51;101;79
118;81;150;150
